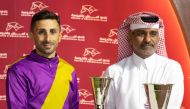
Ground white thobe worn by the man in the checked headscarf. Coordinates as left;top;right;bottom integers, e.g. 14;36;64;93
105;53;184;109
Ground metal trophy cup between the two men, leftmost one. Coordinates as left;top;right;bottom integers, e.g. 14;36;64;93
91;77;111;109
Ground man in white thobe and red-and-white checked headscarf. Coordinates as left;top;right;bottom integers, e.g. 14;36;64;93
104;12;184;109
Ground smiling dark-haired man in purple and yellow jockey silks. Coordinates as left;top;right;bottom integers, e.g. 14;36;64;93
7;10;79;109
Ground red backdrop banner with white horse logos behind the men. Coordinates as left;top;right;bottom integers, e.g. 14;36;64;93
0;0;190;109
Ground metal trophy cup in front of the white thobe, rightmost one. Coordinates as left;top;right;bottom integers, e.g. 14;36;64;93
144;84;173;109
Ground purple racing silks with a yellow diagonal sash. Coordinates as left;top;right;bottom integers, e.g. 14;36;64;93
7;51;79;109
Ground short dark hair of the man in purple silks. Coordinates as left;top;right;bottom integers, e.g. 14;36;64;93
30;10;61;31
